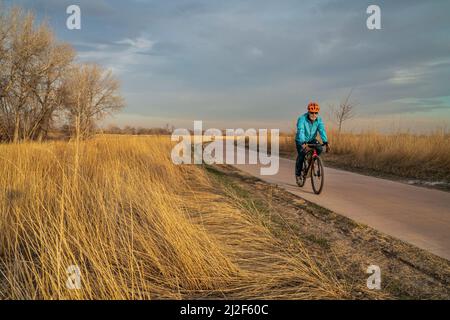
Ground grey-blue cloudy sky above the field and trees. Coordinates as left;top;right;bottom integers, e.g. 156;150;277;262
3;0;450;130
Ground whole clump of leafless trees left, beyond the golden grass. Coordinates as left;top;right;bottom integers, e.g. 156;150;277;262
0;3;124;142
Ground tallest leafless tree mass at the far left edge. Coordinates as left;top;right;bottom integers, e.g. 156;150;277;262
0;8;75;142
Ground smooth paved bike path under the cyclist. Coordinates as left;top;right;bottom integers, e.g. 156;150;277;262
235;150;450;260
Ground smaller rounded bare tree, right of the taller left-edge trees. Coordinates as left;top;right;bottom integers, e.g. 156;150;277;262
63;64;124;140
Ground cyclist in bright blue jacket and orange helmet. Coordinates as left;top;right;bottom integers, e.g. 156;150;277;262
295;102;330;184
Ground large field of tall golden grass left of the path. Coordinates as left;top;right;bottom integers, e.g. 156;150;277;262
0;136;348;299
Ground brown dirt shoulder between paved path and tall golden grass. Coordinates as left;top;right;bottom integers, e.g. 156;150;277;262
208;165;450;299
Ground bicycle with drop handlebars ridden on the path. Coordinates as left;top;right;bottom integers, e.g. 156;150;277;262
298;144;325;194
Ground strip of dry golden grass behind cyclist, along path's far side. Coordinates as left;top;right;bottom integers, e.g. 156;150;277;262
280;131;450;182
